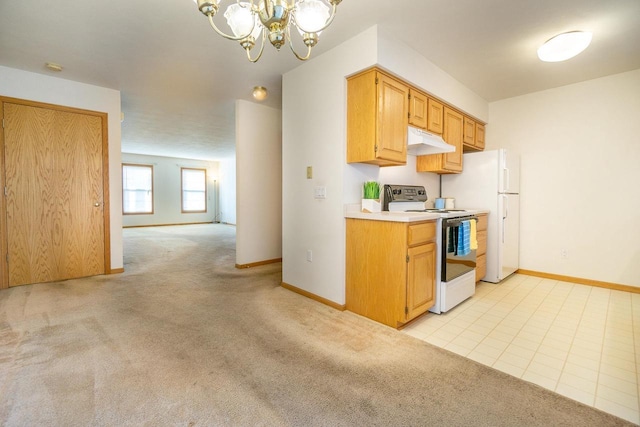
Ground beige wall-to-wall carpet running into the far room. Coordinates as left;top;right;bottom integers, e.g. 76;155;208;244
0;224;630;426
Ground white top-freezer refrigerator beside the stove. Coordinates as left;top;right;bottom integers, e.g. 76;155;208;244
441;149;520;283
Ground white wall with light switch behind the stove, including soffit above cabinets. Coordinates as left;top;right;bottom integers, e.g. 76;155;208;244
282;26;487;304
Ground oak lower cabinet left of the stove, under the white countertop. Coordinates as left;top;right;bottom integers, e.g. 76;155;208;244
346;218;436;328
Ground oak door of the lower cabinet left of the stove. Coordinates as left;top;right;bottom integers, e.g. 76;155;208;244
406;243;436;321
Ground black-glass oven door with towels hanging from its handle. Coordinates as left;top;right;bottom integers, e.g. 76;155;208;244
441;217;477;282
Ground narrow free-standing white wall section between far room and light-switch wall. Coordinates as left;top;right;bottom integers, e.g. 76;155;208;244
236;100;282;265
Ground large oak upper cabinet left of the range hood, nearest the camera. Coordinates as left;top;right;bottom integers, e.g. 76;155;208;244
347;69;409;166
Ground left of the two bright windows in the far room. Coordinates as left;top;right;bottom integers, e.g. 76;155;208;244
122;163;153;215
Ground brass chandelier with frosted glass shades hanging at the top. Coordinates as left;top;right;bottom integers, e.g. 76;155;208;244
197;0;342;62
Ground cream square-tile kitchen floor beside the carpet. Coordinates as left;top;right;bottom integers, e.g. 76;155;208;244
404;274;640;424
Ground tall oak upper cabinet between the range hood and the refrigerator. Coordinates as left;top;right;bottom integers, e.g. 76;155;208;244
416;105;464;173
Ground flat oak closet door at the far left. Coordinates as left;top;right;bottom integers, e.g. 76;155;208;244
4;103;105;286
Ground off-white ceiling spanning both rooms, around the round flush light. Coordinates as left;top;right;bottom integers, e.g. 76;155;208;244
0;0;640;160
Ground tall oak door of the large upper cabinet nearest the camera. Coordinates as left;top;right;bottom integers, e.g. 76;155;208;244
376;73;409;163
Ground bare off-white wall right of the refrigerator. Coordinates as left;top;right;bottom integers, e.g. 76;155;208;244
487;70;640;287
